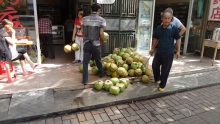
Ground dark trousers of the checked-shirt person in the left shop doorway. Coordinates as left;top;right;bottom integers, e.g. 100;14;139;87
40;34;55;59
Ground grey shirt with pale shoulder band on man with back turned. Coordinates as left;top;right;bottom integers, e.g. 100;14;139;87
81;13;106;46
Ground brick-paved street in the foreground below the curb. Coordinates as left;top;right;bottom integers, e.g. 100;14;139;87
22;85;220;124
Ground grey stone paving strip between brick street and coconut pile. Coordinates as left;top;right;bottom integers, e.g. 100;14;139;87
0;70;220;123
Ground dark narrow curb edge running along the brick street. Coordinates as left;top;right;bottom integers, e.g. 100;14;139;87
0;69;220;124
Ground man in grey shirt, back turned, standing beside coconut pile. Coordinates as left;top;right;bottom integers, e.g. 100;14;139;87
81;4;106;84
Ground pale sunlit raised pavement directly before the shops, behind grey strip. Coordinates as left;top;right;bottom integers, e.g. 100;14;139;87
0;56;220;98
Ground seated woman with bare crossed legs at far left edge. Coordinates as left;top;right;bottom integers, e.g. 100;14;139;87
2;19;38;75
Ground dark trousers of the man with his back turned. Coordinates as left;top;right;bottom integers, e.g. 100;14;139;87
82;41;104;84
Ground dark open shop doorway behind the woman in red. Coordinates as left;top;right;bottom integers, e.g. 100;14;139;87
37;0;91;63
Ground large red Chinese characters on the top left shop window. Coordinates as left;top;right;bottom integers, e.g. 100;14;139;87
0;0;21;28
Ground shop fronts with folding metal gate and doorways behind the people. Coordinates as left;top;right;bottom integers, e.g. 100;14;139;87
0;0;220;62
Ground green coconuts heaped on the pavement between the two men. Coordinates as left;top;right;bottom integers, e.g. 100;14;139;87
79;47;152;94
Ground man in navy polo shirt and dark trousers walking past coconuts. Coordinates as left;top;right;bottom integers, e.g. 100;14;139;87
149;11;180;92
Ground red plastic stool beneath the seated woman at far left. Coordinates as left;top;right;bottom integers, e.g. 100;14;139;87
0;61;16;83
